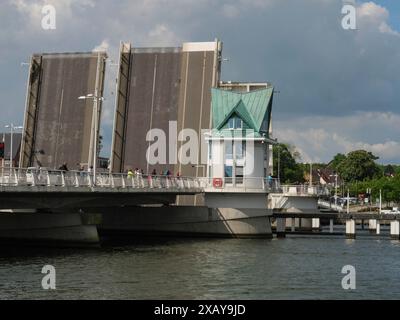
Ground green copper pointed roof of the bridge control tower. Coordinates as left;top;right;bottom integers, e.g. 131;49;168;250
211;87;274;132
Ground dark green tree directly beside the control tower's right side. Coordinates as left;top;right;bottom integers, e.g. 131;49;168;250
273;143;304;183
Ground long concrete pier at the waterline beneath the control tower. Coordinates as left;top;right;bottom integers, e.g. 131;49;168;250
93;206;272;238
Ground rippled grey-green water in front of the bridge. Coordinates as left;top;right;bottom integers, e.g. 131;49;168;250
0;232;400;299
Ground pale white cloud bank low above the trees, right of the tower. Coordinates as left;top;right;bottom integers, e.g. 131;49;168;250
274;112;400;163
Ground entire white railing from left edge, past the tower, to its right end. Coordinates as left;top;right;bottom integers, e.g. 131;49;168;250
0;167;329;196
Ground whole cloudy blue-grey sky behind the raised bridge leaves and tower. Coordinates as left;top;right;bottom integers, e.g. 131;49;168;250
0;0;400;164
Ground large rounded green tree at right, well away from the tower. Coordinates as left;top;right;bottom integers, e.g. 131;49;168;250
337;150;380;182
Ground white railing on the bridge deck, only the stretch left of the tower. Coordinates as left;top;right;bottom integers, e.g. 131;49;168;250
0;167;202;189
